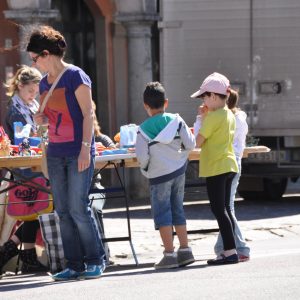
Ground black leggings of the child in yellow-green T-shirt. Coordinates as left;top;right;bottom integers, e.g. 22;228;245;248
206;172;236;250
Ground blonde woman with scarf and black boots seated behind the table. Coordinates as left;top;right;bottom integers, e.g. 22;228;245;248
0;66;47;274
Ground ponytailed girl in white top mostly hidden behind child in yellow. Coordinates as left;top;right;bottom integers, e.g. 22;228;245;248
214;92;250;262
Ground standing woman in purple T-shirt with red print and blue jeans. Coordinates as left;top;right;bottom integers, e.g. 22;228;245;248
27;26;105;280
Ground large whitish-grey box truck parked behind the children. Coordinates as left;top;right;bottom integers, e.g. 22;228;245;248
158;0;300;199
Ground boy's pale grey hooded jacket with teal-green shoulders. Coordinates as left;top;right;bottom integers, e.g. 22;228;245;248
136;113;195;184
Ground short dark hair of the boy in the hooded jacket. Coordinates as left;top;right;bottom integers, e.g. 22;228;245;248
144;81;166;108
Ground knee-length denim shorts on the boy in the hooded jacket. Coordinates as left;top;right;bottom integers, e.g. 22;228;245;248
150;174;186;229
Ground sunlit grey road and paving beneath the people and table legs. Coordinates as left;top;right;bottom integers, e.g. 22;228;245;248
0;186;300;300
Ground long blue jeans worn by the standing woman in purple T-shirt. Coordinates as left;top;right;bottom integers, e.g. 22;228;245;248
47;157;105;272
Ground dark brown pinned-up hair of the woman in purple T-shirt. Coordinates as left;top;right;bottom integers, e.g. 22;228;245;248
26;25;67;57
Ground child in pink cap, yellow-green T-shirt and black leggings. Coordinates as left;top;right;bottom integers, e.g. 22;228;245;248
191;73;239;265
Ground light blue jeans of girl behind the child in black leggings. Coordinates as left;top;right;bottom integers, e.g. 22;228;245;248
214;157;250;256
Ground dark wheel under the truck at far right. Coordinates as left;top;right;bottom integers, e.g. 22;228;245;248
263;178;288;201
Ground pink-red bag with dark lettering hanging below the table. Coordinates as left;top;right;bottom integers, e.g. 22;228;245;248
7;177;53;221
